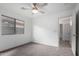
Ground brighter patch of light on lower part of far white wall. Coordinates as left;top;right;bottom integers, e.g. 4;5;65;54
33;25;59;47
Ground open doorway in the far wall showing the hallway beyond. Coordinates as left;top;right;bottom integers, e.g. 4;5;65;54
59;16;72;47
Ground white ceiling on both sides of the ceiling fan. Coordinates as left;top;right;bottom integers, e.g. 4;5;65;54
0;3;76;16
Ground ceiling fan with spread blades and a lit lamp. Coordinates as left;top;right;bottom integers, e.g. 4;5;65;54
21;3;47;14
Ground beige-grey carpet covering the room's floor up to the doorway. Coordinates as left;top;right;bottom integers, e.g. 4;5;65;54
0;43;73;56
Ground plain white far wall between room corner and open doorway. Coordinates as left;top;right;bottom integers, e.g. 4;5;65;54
33;10;72;47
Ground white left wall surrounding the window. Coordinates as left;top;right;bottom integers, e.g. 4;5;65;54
0;10;32;51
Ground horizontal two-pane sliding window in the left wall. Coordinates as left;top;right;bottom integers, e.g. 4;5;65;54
1;15;24;35
